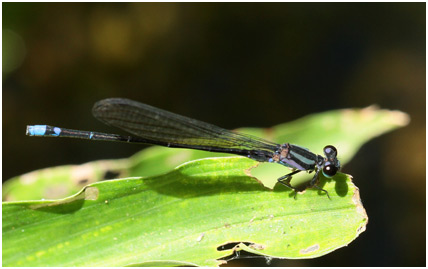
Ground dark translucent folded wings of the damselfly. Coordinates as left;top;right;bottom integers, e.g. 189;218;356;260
92;98;279;153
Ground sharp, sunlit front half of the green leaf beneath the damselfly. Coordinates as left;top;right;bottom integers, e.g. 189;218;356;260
3;157;367;266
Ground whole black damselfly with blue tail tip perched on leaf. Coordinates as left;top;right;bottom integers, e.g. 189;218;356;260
27;98;340;198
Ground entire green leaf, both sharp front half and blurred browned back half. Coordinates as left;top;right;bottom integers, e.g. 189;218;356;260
2;104;408;266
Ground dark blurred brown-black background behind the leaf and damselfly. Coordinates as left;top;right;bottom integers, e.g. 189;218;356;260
2;3;426;266
